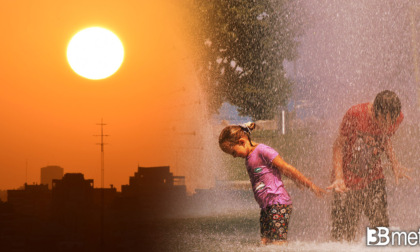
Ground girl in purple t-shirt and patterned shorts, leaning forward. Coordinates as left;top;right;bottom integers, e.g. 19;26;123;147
219;123;325;245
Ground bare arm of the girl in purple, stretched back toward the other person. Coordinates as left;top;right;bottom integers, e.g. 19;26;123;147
273;156;326;197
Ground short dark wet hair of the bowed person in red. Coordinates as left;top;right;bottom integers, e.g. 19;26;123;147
373;90;401;122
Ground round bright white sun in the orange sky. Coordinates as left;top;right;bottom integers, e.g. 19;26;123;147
67;27;124;80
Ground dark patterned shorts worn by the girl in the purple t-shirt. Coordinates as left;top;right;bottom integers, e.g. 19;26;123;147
260;204;292;241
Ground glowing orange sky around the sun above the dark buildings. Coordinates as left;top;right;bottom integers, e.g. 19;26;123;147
0;0;215;190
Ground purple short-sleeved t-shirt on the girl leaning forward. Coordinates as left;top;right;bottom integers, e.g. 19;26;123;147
245;144;292;209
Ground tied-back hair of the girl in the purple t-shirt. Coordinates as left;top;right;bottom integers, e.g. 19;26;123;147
219;122;255;149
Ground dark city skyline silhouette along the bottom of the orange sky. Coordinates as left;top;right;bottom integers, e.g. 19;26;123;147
0;166;189;251
